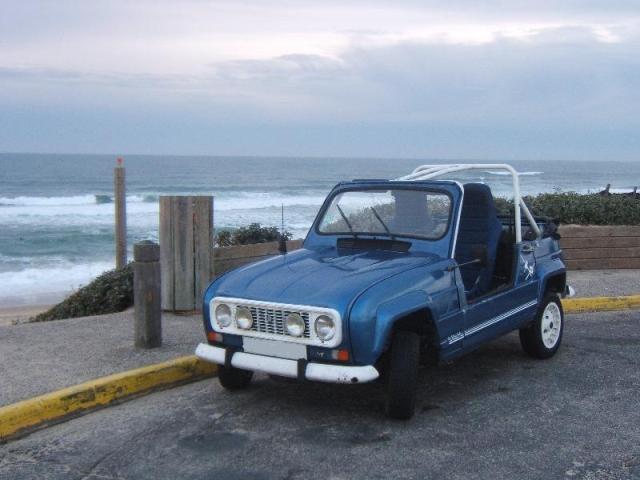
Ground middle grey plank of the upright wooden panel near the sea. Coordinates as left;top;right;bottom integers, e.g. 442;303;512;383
173;197;195;311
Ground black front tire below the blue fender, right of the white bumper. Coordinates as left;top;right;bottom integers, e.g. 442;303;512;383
387;330;420;420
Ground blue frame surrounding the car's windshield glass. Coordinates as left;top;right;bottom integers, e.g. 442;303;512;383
313;182;455;242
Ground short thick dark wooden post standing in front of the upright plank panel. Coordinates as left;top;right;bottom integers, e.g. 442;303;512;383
133;240;162;348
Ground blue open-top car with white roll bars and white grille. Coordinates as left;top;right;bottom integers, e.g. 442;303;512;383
196;164;568;418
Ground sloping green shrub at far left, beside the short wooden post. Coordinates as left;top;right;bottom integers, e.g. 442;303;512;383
32;264;133;322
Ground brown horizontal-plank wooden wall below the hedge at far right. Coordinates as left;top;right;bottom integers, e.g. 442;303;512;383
559;225;640;270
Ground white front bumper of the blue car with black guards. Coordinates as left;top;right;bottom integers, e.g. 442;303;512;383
196;343;379;383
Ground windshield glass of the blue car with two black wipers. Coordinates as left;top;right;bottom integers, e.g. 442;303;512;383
318;189;451;240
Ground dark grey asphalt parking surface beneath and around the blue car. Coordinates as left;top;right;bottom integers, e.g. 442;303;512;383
0;311;640;480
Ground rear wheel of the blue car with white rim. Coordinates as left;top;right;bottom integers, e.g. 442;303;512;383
520;293;564;359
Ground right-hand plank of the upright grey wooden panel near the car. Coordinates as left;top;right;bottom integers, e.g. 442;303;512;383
193;197;213;310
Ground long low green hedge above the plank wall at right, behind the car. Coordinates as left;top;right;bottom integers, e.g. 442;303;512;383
496;192;640;225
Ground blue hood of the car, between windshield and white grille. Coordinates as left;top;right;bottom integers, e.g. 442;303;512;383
216;248;440;315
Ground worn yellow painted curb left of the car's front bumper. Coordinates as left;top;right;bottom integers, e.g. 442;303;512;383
0;355;216;441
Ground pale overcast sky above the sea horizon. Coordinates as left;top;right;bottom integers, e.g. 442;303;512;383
0;0;640;161
